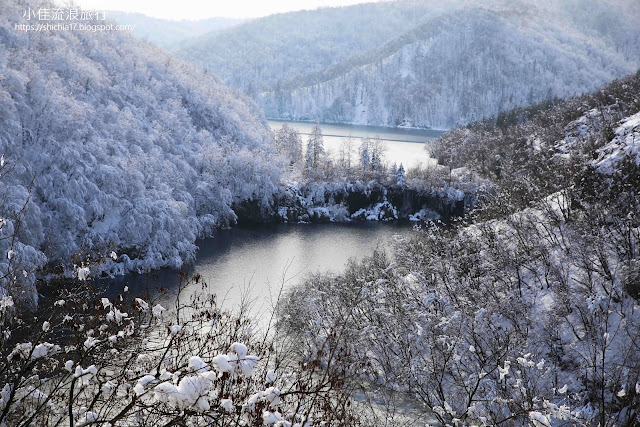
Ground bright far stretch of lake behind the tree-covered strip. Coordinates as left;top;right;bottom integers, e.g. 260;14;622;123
269;120;444;169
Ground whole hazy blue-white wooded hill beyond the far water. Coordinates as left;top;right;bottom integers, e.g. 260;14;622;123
178;0;640;128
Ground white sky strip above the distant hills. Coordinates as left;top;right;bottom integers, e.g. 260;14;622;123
64;0;378;19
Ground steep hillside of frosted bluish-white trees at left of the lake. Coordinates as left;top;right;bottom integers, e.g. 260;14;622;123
0;1;279;302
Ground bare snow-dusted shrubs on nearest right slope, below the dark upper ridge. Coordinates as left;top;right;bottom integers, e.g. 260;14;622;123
280;195;640;426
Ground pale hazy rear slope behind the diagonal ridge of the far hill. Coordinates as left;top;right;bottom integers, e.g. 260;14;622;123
177;0;462;93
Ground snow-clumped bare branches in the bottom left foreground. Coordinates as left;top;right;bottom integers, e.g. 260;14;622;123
0;277;364;426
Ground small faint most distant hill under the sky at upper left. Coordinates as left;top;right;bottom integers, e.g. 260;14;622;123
106;10;243;49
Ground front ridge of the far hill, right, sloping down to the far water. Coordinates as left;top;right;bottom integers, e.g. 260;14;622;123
257;2;640;128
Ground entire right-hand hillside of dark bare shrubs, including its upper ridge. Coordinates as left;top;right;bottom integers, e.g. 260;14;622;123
280;73;640;426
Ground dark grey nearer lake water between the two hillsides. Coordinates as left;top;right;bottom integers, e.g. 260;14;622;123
103;222;412;326
